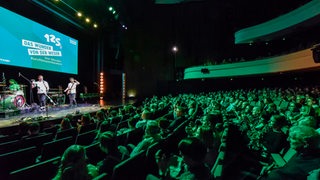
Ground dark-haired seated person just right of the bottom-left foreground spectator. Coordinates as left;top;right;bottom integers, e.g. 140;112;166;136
97;131;123;179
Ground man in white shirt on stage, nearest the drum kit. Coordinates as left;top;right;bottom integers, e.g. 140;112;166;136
31;75;49;109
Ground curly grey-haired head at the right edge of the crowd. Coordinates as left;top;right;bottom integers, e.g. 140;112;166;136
288;125;319;151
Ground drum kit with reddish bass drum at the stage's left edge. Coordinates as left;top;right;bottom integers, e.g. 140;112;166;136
0;84;27;110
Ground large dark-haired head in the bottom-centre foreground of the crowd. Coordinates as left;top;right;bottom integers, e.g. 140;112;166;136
178;137;207;167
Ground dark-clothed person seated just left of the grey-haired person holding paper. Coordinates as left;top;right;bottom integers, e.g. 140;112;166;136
262;115;287;153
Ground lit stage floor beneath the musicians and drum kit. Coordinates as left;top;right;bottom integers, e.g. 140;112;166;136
0;104;108;128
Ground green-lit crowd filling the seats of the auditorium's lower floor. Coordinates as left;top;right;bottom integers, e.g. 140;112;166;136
3;87;320;179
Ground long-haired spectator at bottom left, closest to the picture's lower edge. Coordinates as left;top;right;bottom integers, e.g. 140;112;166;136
53;145;98;180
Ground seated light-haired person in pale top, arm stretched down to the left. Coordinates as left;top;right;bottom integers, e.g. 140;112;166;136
130;121;161;157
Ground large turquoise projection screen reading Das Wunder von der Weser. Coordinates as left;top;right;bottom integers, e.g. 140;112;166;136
0;7;78;74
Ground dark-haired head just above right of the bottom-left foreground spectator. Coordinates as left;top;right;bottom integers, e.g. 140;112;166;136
99;131;118;154
